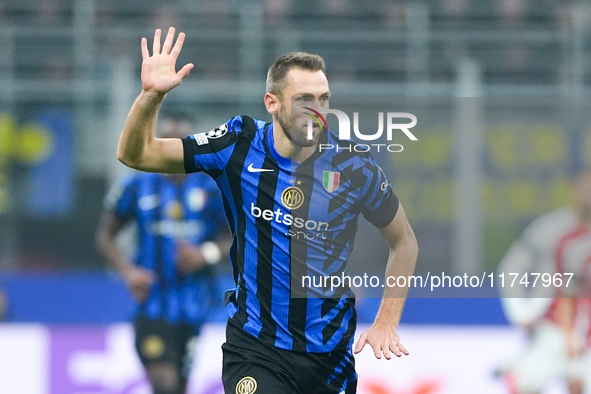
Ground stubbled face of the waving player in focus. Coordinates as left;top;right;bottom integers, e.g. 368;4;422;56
277;68;330;147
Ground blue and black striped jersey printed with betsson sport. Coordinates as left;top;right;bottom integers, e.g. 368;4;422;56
183;116;398;352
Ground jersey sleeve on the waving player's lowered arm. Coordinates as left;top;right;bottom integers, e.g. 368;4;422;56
361;157;400;228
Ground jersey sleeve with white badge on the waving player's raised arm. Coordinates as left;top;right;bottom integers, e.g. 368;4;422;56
182;116;243;178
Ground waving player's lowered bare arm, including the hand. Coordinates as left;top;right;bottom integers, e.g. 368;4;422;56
355;205;419;360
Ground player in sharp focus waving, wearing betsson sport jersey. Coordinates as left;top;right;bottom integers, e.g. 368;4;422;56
118;28;418;394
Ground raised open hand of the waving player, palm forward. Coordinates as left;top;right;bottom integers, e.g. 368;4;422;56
141;27;193;94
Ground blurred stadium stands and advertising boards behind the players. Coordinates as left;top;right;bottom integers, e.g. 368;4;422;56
0;0;591;394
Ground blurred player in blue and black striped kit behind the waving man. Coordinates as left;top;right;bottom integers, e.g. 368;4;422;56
97;114;229;394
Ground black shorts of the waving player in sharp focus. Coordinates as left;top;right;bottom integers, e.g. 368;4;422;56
222;322;357;394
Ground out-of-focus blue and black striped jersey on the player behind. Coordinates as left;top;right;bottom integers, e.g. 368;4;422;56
105;173;226;324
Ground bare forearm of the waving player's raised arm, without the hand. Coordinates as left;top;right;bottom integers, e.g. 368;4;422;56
117;90;164;170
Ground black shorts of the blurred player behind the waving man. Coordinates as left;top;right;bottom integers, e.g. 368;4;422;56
134;316;198;377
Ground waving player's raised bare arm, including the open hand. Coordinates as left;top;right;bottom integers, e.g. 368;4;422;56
117;27;193;173
